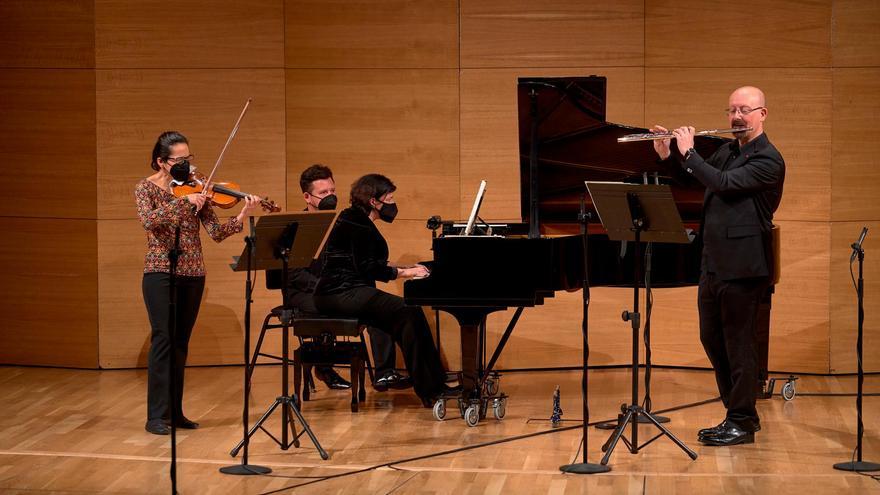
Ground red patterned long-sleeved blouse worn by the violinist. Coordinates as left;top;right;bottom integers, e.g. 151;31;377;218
134;179;243;277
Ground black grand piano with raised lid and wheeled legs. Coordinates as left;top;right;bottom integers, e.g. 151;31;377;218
404;76;726;426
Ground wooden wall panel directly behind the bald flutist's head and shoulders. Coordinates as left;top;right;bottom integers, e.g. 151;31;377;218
645;69;832;221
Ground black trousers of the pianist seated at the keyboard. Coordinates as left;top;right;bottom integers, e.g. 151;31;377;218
315;287;446;398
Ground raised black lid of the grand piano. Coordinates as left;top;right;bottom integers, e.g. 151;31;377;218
517;76;730;233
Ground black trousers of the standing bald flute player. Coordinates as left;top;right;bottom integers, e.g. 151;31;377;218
697;273;769;430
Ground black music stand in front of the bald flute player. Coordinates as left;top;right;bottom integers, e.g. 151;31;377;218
586;181;697;465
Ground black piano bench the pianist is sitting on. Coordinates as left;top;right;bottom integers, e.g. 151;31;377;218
292;315;373;412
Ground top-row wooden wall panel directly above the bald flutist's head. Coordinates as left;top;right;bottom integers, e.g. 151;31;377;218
645;0;831;68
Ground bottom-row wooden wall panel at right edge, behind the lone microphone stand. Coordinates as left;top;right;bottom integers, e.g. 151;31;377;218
829;220;880;373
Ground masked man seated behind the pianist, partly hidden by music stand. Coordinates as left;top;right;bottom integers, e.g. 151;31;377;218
286;165;412;392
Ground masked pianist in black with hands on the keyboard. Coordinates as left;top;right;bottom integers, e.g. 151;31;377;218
315;174;451;407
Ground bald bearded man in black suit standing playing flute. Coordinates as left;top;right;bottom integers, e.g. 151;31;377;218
654;86;785;445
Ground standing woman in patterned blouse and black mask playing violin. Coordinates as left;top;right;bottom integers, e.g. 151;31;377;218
135;131;260;435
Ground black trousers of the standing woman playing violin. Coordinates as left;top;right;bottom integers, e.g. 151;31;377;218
142;273;205;421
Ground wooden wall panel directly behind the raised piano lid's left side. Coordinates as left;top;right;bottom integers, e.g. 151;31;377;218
459;67;645;221
